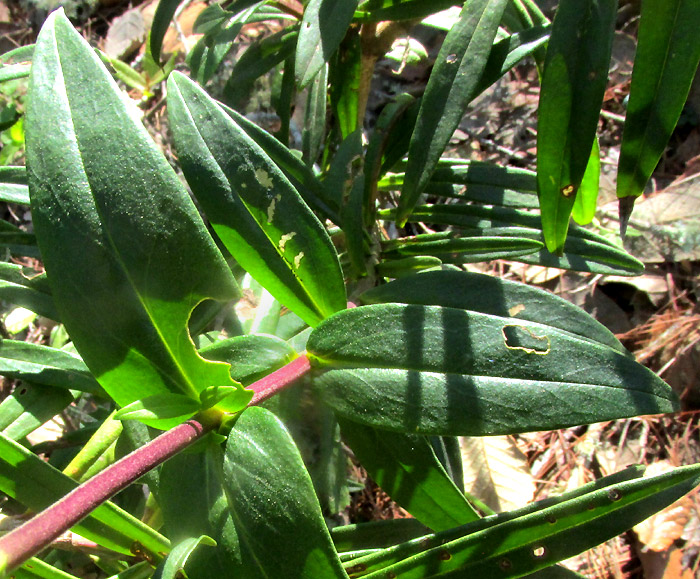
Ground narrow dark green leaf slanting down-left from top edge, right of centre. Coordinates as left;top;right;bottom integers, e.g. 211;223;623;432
397;0;507;225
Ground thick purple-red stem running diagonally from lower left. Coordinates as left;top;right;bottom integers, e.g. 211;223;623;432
0;356;311;575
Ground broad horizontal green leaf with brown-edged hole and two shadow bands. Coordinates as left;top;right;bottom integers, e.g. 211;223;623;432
307;304;677;435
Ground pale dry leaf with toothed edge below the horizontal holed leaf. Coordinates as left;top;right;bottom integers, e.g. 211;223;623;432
460;436;535;512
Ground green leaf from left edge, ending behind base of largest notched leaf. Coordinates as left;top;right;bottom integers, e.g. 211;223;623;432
0;340;103;395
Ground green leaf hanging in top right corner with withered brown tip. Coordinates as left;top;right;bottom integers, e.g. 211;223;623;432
617;0;700;226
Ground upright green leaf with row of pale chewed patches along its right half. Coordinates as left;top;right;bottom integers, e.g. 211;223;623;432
168;73;346;326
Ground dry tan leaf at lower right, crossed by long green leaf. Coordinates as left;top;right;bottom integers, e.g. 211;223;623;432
634;461;693;551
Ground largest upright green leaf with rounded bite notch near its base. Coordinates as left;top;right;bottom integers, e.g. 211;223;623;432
26;12;250;428
